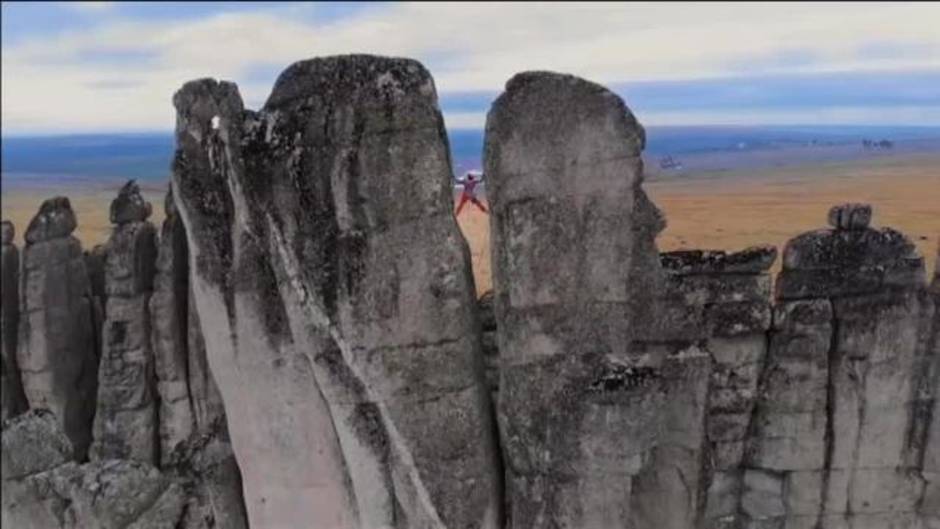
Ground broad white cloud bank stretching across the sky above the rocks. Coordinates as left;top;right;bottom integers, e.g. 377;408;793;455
2;3;940;133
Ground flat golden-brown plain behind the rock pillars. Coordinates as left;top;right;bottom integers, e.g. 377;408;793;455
2;153;940;293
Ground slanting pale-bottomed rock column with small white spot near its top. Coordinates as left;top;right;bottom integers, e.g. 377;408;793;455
173;73;358;529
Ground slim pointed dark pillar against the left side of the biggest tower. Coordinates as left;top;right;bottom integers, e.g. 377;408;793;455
150;187;247;529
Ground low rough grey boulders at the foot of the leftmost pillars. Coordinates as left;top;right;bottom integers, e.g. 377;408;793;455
0;410;185;529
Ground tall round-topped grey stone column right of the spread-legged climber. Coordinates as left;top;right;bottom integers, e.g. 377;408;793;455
484;72;672;529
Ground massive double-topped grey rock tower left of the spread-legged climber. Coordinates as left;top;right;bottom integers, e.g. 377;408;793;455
173;56;501;527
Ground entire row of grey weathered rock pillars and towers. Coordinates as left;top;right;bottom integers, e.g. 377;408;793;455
0;55;940;529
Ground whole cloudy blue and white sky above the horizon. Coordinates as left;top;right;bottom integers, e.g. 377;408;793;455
0;2;940;136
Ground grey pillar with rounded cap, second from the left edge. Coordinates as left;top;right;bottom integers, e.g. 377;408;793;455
17;197;98;460
